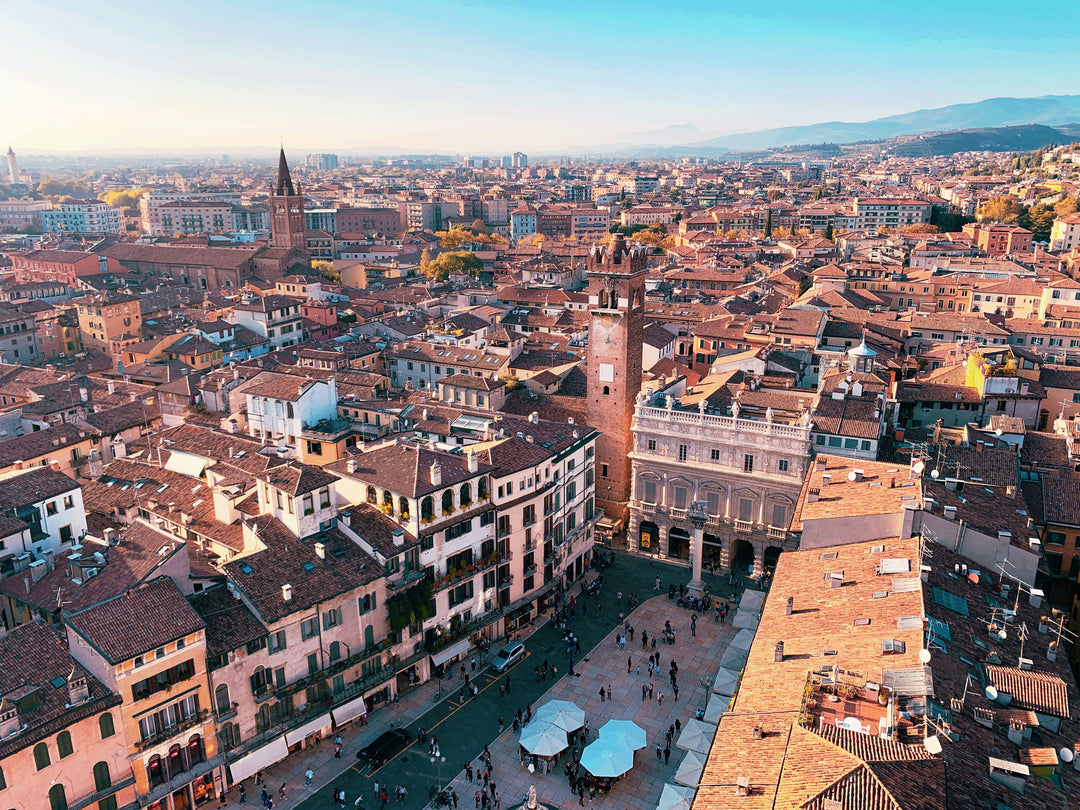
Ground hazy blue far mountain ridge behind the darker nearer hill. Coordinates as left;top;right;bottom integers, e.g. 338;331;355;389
686;95;1080;153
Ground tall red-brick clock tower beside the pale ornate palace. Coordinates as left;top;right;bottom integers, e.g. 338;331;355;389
586;233;647;527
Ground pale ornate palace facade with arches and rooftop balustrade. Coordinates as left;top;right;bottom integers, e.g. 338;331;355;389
629;397;810;575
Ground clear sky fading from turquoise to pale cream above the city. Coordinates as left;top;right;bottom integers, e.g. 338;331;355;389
0;0;1080;154
